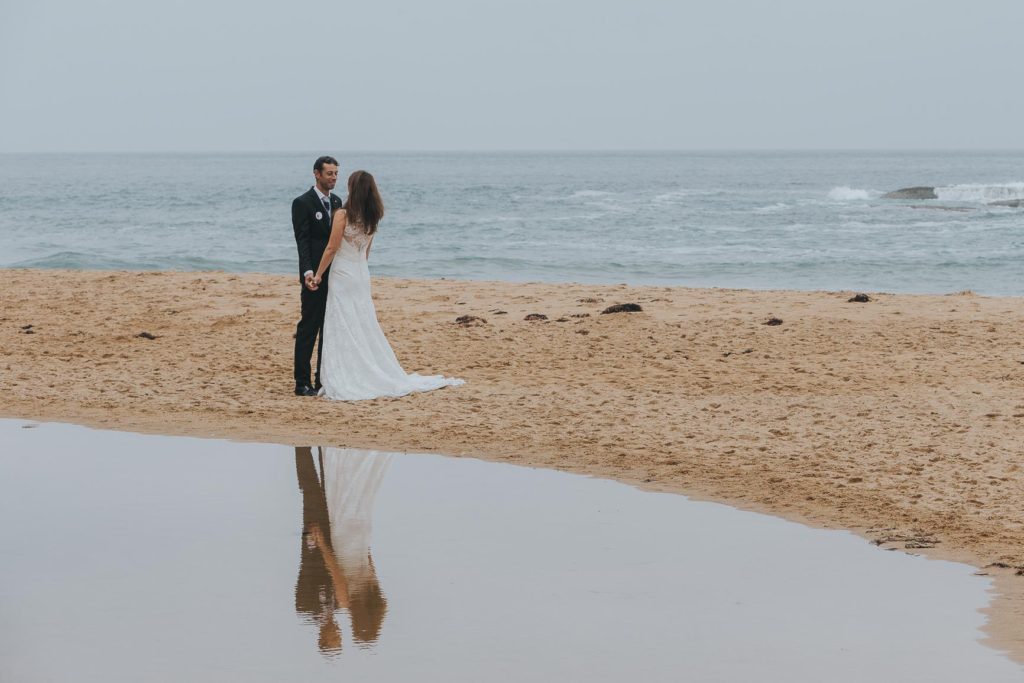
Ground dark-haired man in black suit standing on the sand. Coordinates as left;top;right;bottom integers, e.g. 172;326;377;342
292;157;342;396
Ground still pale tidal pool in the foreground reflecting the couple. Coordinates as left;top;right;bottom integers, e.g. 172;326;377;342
0;420;1024;683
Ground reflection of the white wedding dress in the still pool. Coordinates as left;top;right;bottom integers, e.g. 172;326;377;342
324;449;391;591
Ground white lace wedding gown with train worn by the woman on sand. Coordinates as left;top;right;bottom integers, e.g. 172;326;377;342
321;223;463;400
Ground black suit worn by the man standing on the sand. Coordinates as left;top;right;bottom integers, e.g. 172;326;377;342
292;187;343;386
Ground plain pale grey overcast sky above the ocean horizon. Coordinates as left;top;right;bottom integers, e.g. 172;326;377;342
0;0;1024;152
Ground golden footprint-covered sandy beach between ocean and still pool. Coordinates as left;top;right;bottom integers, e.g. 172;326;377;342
0;269;1024;659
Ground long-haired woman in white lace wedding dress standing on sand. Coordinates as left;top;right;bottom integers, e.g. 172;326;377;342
313;171;463;400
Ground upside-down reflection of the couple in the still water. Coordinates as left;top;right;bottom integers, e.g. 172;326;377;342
295;447;391;654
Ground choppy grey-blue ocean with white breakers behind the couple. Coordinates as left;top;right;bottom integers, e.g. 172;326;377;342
0;151;1024;295
